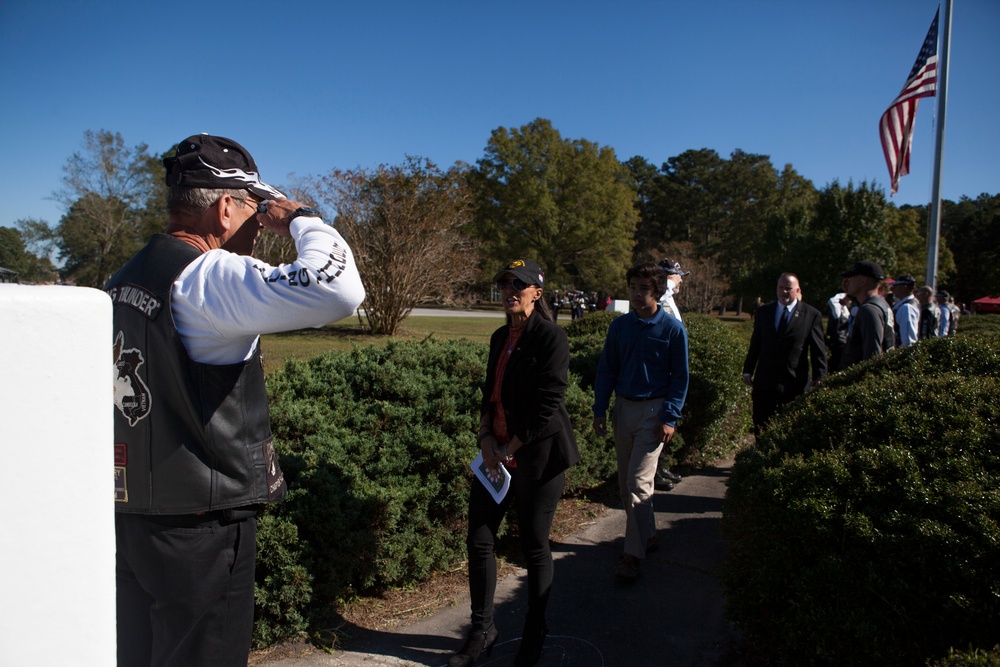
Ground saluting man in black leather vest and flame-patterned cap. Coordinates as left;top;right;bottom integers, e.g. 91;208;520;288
105;134;365;666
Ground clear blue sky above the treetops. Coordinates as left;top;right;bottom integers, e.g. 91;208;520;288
0;0;1000;234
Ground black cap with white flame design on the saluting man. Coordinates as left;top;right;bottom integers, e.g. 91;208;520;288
163;134;285;199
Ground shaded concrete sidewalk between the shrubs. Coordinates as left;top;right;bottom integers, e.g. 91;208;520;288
265;461;739;667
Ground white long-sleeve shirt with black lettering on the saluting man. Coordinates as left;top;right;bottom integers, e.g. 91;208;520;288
171;217;365;365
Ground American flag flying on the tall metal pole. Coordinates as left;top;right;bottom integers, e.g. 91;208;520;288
878;9;940;194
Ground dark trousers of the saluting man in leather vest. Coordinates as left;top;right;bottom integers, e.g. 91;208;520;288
115;513;257;667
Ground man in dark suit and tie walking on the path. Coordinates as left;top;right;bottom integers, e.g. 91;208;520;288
743;273;826;435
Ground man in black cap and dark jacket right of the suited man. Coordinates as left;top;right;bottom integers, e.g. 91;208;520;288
840;261;894;369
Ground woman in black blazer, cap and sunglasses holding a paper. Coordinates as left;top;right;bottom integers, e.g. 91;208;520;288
448;260;580;667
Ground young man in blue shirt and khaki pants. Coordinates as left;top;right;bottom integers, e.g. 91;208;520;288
594;263;688;580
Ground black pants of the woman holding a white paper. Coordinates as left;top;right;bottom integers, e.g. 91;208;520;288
467;468;566;630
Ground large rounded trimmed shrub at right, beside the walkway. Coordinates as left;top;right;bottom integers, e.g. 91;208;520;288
722;337;1000;665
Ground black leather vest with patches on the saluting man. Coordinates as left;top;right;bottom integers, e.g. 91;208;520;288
105;234;286;514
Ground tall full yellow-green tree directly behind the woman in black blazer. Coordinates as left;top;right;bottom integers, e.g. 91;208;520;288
469;118;638;292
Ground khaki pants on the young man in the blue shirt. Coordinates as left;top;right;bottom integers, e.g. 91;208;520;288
612;398;663;558
